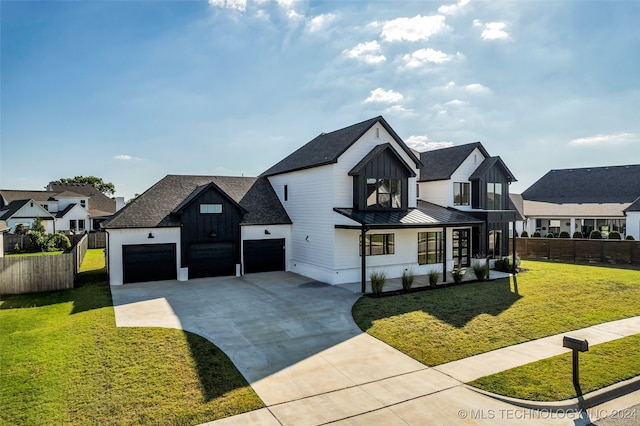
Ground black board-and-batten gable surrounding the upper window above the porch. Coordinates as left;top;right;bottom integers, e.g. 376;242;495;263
349;143;416;210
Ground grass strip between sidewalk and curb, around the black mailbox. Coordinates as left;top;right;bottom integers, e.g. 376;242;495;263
469;334;640;401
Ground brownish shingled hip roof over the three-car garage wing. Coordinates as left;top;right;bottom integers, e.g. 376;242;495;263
105;175;291;229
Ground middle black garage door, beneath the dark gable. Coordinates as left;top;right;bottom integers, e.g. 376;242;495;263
188;243;236;279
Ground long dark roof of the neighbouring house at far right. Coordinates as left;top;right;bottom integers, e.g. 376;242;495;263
522;164;640;204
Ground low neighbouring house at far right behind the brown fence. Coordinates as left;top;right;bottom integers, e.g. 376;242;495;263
522;164;640;239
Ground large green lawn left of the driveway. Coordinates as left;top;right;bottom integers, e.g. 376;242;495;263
0;250;264;425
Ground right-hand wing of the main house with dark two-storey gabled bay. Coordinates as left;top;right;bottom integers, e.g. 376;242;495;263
418;142;519;266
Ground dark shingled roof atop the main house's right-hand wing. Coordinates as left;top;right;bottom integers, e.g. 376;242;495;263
420;142;488;182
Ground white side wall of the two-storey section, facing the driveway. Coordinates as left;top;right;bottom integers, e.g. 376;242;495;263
269;165;338;283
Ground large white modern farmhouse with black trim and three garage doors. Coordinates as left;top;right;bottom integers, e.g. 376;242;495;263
105;117;515;285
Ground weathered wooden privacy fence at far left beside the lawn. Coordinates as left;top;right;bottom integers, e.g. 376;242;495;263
0;236;89;294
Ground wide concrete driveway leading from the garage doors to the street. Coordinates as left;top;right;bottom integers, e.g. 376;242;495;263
111;272;589;425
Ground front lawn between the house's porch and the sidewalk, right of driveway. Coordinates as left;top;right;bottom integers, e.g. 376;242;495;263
353;261;640;366
